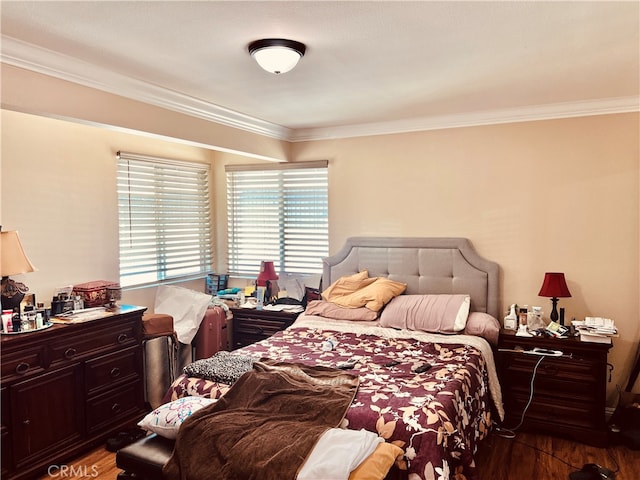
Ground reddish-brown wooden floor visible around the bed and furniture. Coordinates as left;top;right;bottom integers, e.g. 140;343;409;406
40;433;640;480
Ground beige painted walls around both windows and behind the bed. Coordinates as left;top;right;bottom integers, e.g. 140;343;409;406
0;73;640;404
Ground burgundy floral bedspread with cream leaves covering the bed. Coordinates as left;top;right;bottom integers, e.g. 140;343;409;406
165;316;502;480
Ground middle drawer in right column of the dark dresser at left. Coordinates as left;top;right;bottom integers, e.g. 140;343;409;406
85;347;141;395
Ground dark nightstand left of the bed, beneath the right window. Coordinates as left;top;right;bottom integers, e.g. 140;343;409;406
231;308;300;350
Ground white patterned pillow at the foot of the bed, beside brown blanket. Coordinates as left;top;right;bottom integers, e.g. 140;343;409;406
138;397;217;439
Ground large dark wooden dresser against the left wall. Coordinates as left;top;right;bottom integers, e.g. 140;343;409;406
0;305;146;479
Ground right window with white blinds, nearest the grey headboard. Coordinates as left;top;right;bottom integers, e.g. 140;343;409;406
226;161;329;276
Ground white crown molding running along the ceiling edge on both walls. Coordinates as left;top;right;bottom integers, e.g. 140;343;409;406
0;35;640;142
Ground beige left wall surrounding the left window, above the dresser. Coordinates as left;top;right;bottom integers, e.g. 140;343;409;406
0;110;216;307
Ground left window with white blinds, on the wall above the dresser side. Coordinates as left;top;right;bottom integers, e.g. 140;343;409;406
118;152;212;287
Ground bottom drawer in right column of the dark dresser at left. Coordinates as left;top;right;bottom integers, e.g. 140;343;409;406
87;381;142;434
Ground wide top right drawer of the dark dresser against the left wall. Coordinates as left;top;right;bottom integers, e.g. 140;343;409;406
51;322;137;365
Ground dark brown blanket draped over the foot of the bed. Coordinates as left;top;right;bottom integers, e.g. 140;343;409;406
163;360;358;480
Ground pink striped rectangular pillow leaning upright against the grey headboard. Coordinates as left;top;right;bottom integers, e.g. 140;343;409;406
380;295;471;333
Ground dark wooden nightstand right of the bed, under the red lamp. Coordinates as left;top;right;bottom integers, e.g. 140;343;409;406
497;330;612;446
